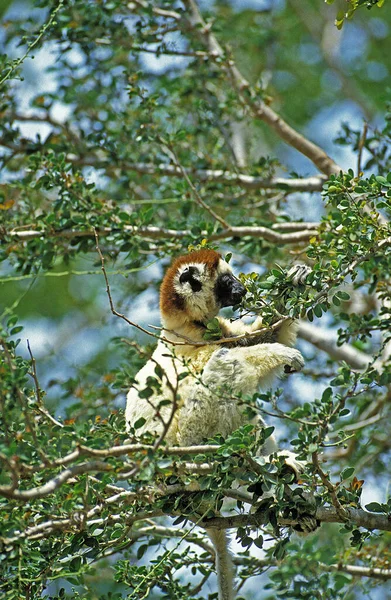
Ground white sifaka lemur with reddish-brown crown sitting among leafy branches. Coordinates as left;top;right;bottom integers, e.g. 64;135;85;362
125;249;304;600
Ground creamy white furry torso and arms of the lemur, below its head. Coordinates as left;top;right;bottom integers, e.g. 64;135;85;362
125;319;303;454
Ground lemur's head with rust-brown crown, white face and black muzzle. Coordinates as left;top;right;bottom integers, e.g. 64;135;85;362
160;250;246;328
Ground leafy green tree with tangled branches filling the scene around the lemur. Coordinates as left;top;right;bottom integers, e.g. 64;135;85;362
0;0;391;600
